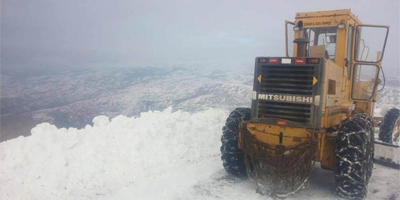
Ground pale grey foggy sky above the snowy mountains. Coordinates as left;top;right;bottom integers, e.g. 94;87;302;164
1;0;400;76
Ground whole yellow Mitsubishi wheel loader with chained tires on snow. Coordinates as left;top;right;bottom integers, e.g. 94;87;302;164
221;10;400;198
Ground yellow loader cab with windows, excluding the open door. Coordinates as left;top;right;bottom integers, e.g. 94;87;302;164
285;10;361;66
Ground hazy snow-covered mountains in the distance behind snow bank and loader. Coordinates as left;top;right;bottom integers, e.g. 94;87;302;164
0;67;400;141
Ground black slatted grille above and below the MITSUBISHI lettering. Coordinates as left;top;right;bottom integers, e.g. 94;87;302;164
258;65;316;123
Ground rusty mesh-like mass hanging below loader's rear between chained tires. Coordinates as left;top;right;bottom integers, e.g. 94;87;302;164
240;128;317;197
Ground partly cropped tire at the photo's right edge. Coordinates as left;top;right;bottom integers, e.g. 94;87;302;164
379;108;400;144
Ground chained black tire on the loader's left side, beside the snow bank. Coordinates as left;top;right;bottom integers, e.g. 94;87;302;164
221;108;250;177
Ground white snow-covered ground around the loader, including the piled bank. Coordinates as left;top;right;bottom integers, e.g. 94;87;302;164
0;108;400;200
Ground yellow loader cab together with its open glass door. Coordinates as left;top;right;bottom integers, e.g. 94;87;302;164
285;9;389;114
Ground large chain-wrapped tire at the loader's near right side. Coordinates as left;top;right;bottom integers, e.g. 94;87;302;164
335;113;374;199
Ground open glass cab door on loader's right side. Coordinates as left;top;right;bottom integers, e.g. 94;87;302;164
351;24;389;115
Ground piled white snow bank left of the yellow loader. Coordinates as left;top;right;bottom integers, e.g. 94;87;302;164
0;108;228;200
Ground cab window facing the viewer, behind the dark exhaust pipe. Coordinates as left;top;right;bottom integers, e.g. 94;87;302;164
303;27;337;60
